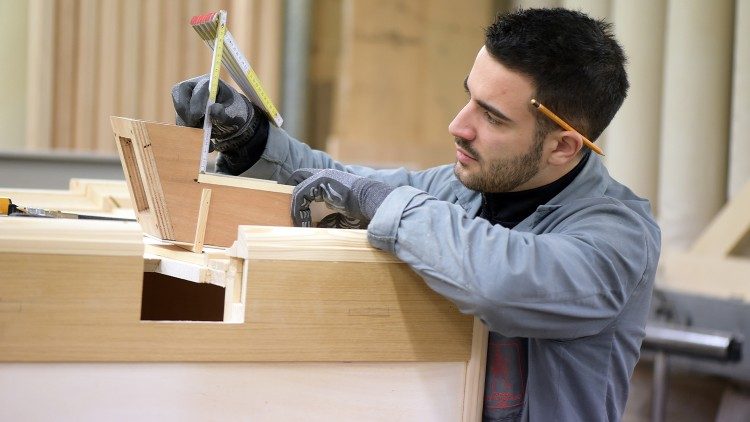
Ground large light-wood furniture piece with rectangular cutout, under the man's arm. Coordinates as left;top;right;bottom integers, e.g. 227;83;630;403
0;217;487;421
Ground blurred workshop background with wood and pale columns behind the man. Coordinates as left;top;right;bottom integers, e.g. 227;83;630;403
0;0;750;421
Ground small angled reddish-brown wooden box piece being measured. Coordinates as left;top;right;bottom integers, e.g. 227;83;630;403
111;117;292;247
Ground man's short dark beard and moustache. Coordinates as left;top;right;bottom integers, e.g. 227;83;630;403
453;136;542;193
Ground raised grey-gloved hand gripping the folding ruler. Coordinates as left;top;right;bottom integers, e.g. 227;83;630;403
172;75;260;152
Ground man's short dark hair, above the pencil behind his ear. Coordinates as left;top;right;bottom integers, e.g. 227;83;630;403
485;8;630;141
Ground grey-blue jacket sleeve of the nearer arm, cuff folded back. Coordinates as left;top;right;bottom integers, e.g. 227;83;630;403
368;187;659;339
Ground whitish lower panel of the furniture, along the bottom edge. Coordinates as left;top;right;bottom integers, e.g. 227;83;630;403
0;362;470;422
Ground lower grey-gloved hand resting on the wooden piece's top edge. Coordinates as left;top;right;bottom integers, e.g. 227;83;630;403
287;169;393;227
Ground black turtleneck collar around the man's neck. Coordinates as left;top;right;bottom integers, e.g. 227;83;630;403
478;152;590;229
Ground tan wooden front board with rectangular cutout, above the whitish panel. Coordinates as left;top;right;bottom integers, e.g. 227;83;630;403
0;217;473;362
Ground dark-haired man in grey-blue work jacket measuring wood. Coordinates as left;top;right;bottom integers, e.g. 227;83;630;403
173;9;660;421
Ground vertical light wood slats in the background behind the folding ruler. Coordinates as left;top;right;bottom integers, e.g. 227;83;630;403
26;0;281;153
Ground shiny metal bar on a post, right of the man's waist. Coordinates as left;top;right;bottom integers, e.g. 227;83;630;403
642;323;743;422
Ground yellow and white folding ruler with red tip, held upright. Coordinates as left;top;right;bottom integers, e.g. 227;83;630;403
190;10;284;174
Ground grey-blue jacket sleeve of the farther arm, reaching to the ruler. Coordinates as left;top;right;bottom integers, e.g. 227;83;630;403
241;126;453;194
